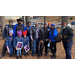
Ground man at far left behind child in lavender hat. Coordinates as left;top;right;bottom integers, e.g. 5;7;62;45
1;20;14;58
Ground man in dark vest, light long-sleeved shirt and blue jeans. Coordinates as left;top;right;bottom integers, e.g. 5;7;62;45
30;23;40;56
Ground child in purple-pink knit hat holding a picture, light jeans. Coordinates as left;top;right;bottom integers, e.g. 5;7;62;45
13;30;23;59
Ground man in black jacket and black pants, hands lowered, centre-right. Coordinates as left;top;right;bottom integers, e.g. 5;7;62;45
38;23;49;57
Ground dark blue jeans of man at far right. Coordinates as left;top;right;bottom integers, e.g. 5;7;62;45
63;42;73;59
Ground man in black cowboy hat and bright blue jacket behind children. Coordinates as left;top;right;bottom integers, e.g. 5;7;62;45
13;18;26;54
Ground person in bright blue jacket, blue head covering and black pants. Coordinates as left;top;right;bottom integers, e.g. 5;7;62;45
48;23;58;59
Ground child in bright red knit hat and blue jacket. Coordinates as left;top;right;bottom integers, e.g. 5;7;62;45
23;31;29;56
